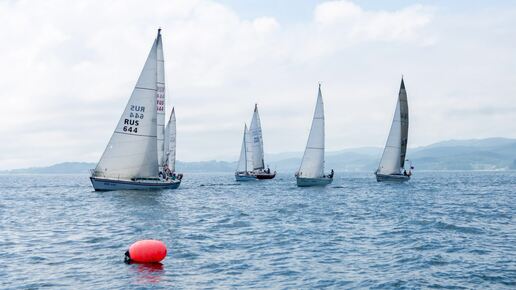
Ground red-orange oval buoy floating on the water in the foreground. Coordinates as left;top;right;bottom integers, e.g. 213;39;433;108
125;240;167;263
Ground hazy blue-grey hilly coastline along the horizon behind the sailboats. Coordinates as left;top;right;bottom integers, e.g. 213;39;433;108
0;138;516;174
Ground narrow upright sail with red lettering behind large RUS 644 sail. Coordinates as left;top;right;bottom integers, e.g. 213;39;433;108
156;30;165;167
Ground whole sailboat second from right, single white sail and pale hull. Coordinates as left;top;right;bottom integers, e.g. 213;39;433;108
296;84;333;187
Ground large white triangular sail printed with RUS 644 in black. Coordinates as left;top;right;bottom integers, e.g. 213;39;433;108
94;34;158;179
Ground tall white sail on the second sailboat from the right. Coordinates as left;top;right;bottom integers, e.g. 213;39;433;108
298;85;324;178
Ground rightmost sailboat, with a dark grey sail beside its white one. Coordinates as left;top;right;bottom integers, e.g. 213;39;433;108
375;78;413;182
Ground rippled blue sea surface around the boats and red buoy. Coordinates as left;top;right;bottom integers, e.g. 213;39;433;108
0;172;516;289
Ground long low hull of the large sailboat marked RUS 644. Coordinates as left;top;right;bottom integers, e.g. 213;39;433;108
90;177;181;191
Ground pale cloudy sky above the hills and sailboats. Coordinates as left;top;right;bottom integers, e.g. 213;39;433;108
0;0;516;170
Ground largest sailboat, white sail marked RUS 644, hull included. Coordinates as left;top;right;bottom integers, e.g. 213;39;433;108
90;29;181;191
